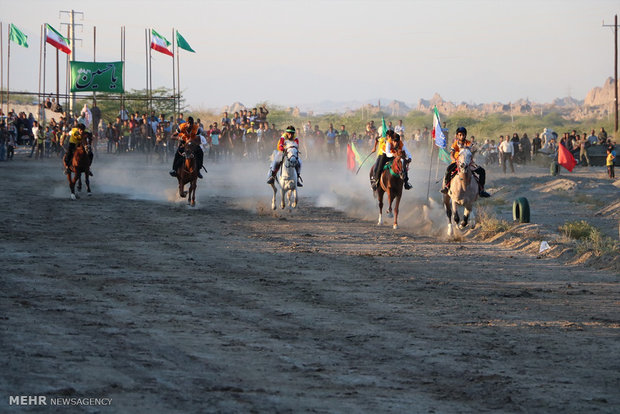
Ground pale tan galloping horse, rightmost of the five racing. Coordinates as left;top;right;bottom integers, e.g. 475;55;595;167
443;148;479;236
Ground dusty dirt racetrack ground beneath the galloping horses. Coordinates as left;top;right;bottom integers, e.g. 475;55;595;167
0;147;620;413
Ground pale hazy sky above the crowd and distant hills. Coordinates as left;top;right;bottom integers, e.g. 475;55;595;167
0;0;620;109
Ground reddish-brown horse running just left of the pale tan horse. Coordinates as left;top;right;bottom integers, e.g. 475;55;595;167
370;150;407;230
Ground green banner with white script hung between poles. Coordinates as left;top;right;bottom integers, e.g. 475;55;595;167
71;61;124;93
